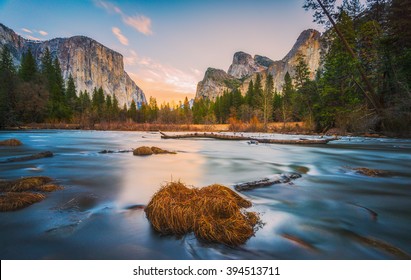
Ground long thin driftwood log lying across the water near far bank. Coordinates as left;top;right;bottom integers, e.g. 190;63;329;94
160;131;338;144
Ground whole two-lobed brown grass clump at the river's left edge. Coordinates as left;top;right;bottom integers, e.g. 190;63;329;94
0;176;63;211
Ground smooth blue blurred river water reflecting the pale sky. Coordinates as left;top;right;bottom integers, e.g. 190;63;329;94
0;130;411;259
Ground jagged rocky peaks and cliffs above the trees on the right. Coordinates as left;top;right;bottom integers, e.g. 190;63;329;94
196;29;321;100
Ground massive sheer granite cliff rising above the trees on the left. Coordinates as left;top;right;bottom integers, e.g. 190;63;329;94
0;24;146;106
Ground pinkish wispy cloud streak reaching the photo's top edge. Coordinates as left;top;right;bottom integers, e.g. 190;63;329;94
94;0;153;35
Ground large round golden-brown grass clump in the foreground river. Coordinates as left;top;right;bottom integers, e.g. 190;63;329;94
145;182;260;246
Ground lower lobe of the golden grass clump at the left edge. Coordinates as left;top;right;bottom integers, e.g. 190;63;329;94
0;192;46;212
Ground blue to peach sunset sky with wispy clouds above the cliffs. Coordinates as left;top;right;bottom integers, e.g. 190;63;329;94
0;0;321;103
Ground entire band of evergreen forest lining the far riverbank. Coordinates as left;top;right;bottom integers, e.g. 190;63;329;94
0;0;411;135
